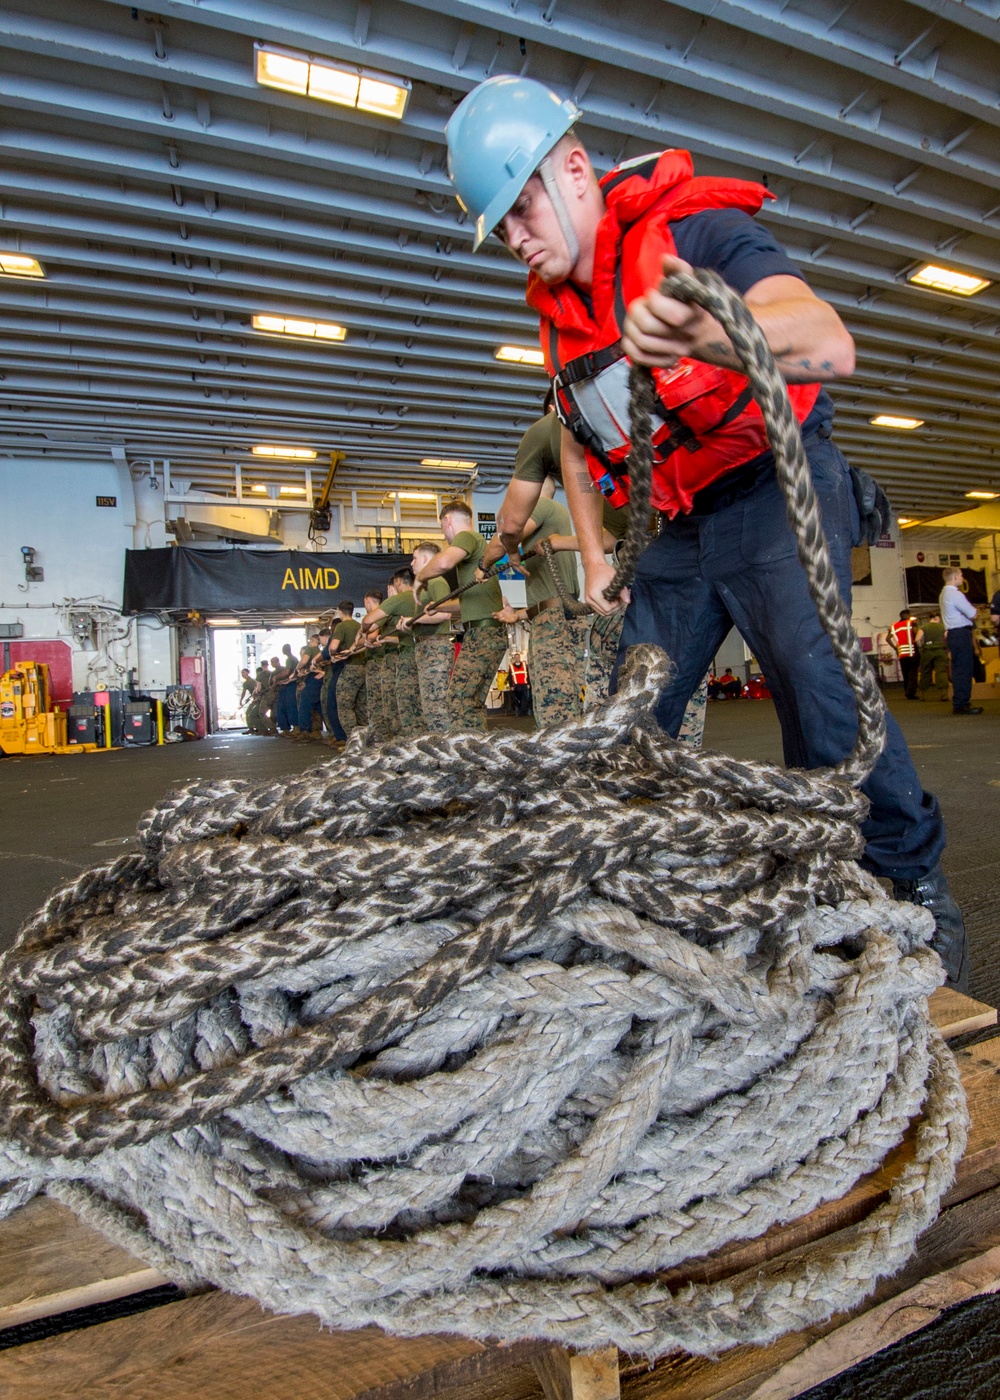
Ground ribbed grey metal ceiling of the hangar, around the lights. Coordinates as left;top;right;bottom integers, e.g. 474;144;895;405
0;0;1000;517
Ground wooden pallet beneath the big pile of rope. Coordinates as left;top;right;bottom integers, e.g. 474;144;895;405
0;991;1000;1400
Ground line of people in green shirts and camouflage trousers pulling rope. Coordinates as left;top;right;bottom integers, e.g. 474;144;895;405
244;490;704;748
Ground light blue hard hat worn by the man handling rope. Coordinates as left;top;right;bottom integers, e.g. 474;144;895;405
444;74;580;249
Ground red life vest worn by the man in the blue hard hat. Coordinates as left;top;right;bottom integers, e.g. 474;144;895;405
527;151;819;518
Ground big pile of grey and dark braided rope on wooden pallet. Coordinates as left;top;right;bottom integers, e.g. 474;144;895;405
0;274;966;1355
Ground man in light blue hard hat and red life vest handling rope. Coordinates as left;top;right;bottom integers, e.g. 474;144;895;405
447;77;969;990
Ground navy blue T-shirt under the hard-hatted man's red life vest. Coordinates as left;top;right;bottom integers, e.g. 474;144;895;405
669;209;833;433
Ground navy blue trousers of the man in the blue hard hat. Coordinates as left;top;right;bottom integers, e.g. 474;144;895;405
616;434;944;879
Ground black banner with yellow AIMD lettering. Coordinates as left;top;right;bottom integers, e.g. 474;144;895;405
122;546;410;613
